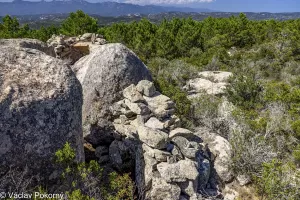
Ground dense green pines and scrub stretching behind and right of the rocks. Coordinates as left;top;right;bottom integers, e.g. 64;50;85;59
0;11;300;200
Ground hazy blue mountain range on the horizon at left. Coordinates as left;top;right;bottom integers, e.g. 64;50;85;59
0;0;213;16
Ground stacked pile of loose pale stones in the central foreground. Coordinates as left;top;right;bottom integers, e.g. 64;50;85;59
109;80;216;200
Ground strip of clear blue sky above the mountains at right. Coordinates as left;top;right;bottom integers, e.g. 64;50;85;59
0;0;300;12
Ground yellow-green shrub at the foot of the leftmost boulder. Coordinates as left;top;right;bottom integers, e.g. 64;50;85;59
55;143;135;200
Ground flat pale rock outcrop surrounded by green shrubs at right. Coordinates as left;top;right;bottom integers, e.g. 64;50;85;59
184;71;232;98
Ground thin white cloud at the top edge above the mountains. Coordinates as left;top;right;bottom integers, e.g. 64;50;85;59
125;0;215;5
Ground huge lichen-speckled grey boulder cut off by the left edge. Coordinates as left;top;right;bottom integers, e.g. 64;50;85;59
0;43;84;180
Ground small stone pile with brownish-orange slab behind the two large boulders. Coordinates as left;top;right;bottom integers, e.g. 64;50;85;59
47;33;106;64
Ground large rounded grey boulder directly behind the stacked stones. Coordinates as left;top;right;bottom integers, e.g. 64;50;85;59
72;44;152;146
